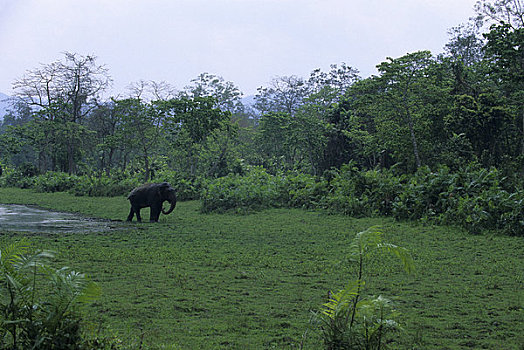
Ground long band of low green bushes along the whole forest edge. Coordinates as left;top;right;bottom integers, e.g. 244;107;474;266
0;163;524;236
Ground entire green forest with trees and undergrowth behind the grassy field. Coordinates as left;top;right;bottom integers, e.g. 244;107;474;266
0;1;524;235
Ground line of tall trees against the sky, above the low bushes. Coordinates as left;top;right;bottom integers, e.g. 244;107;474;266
0;0;524;185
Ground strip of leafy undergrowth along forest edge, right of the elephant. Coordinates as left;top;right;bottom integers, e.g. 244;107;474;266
202;163;524;236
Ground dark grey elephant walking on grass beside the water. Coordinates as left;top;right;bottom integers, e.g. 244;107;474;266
127;182;176;222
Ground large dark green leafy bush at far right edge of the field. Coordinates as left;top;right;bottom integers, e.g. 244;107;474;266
393;164;524;236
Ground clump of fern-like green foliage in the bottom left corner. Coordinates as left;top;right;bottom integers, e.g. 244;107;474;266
0;241;100;349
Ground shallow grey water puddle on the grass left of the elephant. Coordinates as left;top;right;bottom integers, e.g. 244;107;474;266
0;204;113;233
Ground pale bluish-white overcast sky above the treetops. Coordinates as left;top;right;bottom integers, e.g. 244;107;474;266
0;0;482;96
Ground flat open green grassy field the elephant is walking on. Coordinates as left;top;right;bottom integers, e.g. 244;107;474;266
0;188;524;349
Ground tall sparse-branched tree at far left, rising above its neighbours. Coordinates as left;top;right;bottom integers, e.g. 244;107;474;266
13;52;111;174
